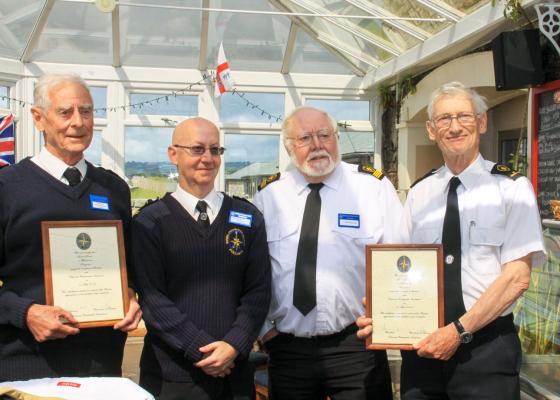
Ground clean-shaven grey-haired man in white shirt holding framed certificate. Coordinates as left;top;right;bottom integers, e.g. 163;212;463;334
358;82;545;400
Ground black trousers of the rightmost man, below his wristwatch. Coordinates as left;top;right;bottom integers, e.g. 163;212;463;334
401;315;521;400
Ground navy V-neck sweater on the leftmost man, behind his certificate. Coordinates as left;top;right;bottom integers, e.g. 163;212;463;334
0;158;131;382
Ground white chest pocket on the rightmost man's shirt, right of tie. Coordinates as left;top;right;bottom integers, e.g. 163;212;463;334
468;225;505;275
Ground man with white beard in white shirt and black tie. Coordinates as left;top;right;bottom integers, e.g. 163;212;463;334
254;107;402;400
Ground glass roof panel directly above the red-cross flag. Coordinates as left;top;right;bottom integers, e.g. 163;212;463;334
207;0;290;72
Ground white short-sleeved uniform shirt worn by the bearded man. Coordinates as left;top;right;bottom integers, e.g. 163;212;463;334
254;162;402;337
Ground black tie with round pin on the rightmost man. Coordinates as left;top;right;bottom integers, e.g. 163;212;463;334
441;176;465;324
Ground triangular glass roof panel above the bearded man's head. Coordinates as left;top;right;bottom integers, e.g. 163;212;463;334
290;29;352;74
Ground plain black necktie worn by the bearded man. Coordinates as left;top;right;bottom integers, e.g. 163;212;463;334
294;183;323;315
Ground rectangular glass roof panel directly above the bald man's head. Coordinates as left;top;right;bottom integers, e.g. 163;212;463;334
119;0;202;68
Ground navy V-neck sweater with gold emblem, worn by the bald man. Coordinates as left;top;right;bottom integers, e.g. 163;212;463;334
132;195;270;381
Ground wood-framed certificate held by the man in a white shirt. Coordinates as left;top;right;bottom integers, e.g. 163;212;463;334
366;244;444;350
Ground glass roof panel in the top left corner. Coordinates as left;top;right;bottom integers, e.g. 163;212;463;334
0;0;45;58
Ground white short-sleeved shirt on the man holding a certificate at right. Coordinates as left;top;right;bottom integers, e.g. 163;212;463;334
401;155;546;315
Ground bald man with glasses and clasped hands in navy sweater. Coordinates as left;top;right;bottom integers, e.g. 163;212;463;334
132;118;270;400
